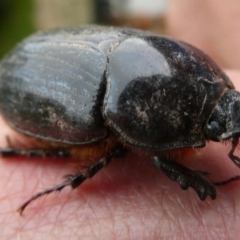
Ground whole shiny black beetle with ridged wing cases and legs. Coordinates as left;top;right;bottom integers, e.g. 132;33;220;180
0;26;240;213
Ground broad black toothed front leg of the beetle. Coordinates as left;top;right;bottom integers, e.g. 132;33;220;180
153;156;216;200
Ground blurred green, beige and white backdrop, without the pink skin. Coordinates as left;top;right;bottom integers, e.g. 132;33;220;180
0;0;168;58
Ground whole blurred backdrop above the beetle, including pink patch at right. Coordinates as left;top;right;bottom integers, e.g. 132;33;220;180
0;0;240;69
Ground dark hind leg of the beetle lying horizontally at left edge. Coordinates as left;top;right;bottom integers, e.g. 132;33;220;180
0;148;71;158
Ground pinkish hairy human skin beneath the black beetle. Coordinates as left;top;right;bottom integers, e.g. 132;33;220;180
0;71;240;240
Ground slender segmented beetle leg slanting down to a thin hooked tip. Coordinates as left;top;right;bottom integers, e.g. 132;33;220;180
18;145;126;215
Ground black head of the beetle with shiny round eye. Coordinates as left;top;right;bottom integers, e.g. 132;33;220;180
205;89;240;141
